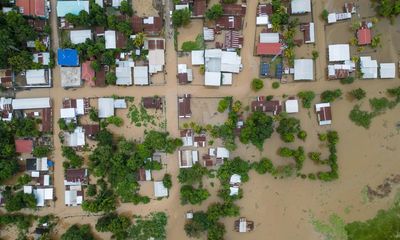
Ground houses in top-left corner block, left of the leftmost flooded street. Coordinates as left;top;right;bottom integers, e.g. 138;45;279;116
0;0;53;89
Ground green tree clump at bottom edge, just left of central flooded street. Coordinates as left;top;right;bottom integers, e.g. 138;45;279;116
128;212;168;240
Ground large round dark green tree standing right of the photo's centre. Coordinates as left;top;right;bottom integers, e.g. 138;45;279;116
240;111;274;151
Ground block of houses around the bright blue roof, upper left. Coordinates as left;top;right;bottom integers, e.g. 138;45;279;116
57;0;165;88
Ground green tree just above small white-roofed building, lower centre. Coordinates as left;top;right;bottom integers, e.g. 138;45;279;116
217;157;251;183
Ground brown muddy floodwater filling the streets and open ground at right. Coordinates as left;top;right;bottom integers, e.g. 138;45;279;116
6;0;400;240
